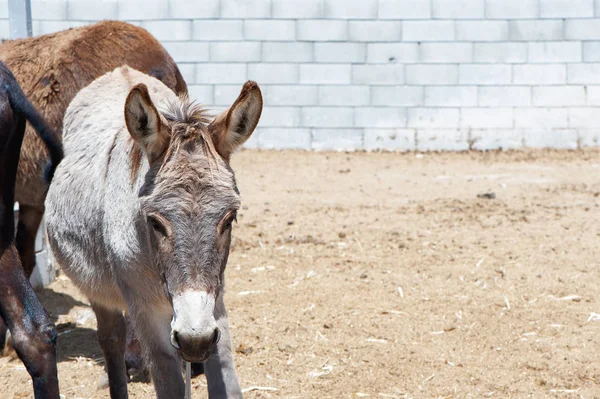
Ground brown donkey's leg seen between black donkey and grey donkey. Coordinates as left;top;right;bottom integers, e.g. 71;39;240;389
16;205;44;278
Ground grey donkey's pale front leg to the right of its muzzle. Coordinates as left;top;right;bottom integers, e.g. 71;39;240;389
204;291;243;399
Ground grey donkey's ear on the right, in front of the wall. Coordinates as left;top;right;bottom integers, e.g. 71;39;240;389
208;81;262;159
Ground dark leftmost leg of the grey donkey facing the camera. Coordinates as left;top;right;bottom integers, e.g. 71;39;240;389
92;303;127;399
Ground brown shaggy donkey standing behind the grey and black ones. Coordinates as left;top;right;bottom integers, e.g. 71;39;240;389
0;21;187;274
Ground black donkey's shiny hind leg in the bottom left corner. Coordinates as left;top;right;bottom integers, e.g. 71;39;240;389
0;245;59;399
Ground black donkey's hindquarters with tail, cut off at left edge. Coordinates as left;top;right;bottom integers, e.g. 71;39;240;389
0;62;63;399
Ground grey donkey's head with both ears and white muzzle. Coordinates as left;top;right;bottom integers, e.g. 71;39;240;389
125;82;262;361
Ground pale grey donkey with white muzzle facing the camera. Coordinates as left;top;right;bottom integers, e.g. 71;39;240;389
46;67;262;399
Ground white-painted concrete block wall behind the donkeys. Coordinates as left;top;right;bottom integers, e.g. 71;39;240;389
0;0;600;151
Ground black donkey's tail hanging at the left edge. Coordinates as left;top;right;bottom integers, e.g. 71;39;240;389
0;63;63;183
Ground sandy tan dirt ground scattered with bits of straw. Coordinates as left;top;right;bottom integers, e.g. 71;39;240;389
0;151;600;399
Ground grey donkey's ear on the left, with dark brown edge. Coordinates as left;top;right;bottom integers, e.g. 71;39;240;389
125;83;169;162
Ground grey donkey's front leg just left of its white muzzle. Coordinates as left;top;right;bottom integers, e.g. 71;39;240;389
132;312;185;399
